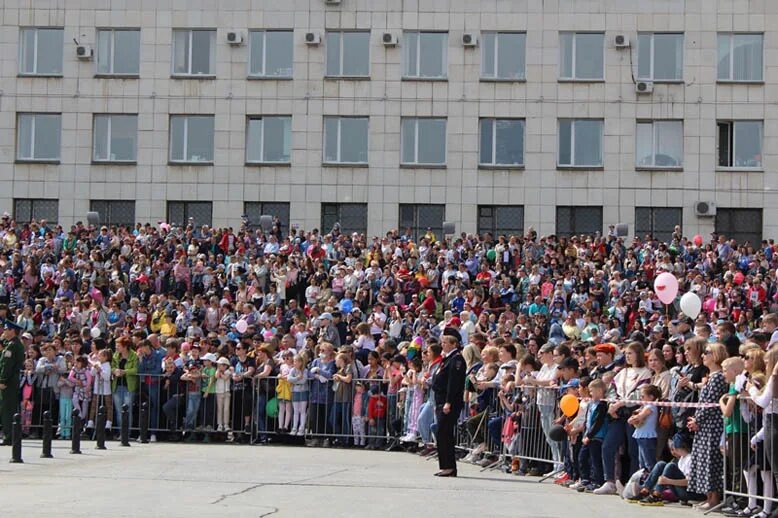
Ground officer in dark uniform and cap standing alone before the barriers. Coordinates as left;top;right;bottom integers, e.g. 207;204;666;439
432;327;466;477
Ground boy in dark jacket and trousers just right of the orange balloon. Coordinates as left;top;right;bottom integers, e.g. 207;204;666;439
576;379;608;492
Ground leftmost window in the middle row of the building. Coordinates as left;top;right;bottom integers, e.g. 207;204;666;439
16;113;62;162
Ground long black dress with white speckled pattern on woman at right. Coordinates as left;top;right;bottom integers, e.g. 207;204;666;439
689;371;729;495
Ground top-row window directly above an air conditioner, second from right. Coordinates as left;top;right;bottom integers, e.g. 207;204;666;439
638;32;683;81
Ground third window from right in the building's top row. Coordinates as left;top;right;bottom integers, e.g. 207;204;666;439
559;32;605;80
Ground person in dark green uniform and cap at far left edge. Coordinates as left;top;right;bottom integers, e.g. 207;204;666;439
0;320;24;446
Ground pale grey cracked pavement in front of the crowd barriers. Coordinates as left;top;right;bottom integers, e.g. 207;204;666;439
0;441;701;518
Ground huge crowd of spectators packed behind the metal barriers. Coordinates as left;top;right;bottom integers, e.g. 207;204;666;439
0;215;778;518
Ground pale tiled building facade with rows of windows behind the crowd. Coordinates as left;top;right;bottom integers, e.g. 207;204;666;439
0;0;778;241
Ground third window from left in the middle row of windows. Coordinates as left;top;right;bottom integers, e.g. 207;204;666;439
170;115;213;163
